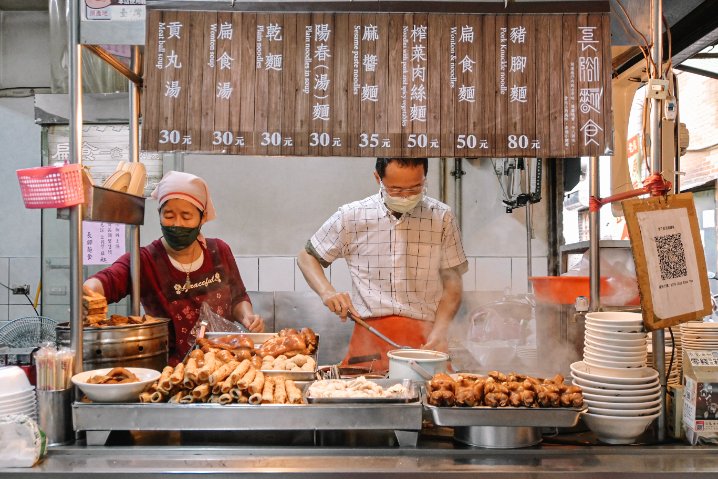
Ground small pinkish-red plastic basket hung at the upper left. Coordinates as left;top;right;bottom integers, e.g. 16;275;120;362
17;163;85;208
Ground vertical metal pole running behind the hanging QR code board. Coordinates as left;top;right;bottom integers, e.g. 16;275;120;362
651;0;666;441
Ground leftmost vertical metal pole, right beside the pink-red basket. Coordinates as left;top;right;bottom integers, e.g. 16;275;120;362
67;0;83;373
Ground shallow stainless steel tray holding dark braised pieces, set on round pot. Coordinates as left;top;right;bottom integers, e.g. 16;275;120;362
424;398;587;427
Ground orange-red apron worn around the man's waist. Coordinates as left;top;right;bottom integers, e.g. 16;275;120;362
342;316;433;373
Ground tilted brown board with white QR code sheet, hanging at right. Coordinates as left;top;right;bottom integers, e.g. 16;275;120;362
623;193;711;331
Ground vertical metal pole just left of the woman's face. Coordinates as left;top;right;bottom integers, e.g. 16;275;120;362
129;45;142;316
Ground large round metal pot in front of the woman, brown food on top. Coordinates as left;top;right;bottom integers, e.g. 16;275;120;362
57;318;169;371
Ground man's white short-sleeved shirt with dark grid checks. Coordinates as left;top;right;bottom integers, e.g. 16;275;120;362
311;194;468;321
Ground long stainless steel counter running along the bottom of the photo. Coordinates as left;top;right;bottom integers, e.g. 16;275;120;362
0;428;718;479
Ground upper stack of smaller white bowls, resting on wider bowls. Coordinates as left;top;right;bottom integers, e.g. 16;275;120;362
583;312;647;368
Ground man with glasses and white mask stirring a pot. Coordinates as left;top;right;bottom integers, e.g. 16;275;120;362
297;158;468;371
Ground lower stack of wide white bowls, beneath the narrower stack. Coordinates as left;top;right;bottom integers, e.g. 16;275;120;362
571;361;661;444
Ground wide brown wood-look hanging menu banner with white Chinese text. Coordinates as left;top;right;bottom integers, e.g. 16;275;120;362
142;10;613;157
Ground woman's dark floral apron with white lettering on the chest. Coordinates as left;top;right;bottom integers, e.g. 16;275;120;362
148;239;232;365
